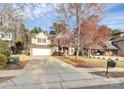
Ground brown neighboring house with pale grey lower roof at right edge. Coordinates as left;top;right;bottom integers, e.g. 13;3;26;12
91;32;124;56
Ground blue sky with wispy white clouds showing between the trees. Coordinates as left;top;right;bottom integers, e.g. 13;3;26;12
22;3;124;31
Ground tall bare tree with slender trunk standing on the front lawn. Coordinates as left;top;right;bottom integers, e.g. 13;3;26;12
56;3;103;59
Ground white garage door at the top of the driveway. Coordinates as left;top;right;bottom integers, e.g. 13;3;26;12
32;48;51;56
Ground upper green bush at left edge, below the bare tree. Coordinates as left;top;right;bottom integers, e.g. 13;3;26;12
0;40;10;56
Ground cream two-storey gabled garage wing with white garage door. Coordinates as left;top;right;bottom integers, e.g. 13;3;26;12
30;31;52;56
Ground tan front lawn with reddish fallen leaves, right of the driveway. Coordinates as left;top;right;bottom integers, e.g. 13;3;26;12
55;56;124;68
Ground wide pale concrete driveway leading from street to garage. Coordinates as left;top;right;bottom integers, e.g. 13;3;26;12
0;56;124;89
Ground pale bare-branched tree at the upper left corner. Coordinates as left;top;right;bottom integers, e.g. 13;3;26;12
0;4;26;42
